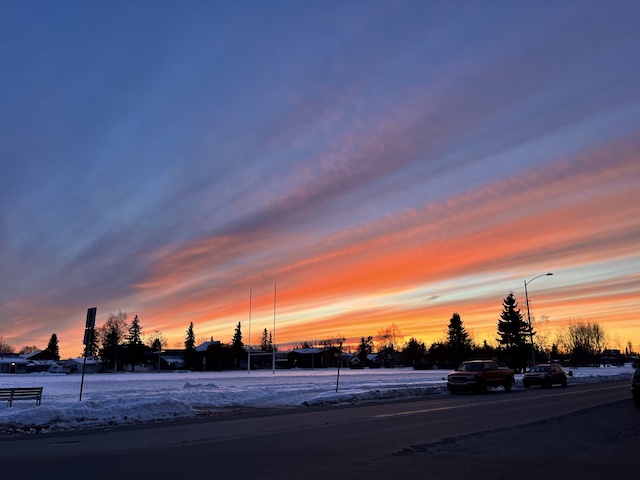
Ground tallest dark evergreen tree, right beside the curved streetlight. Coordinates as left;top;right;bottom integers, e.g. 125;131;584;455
496;292;529;372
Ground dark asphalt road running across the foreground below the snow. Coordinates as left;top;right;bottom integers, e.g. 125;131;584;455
0;382;640;480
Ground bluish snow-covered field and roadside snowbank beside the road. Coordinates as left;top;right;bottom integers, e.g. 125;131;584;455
0;365;633;434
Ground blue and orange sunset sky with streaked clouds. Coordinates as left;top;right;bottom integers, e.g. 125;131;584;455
0;0;640;358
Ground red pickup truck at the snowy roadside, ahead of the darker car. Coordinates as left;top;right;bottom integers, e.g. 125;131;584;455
447;360;515;393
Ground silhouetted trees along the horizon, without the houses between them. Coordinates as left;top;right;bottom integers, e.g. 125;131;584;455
0;292;634;371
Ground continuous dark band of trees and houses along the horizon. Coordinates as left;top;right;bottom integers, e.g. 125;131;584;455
0;292;637;372
